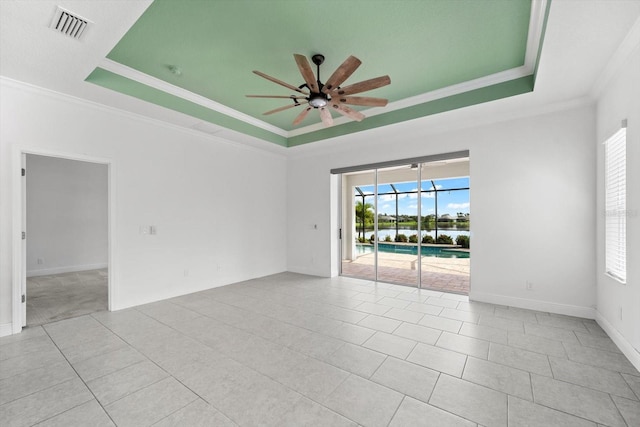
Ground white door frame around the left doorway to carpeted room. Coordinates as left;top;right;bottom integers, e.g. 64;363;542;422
11;147;116;334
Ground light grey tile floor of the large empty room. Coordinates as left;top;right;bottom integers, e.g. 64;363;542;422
0;273;640;427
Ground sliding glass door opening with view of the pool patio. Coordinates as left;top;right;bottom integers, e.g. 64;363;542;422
340;153;471;295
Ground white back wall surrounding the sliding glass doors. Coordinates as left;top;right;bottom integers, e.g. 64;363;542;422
287;105;596;317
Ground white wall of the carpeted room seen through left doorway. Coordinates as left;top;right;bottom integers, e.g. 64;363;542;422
26;154;108;277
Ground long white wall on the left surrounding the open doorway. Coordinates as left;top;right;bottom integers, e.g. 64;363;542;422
0;80;287;331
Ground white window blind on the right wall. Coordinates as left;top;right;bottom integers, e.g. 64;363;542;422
605;128;627;283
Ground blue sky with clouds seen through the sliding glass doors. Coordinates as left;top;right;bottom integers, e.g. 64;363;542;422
356;177;471;218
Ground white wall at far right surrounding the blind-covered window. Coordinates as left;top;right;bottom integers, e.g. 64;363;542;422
594;44;640;369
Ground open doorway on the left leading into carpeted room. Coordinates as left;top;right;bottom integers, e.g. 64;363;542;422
22;154;109;326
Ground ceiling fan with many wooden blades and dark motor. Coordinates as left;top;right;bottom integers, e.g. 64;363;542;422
247;54;391;126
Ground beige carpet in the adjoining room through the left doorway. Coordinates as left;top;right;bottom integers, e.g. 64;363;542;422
27;269;108;326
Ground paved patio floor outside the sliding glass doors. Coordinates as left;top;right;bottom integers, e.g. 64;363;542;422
342;253;470;295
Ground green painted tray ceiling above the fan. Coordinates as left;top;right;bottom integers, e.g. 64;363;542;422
87;0;544;146
